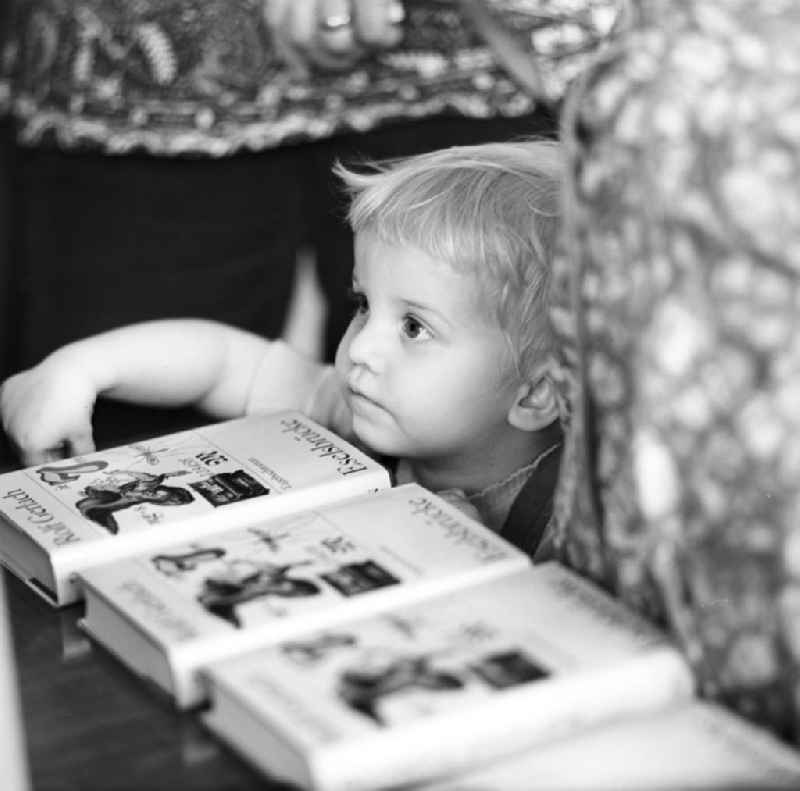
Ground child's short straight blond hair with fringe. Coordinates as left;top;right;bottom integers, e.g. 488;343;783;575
335;140;563;380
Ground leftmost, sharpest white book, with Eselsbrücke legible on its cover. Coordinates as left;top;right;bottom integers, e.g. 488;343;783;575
0;412;390;606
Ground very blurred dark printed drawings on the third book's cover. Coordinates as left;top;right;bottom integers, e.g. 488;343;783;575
223;581;554;735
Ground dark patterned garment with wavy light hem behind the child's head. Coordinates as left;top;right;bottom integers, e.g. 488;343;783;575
0;0;619;156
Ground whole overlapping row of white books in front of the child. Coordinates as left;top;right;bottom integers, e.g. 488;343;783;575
0;412;800;791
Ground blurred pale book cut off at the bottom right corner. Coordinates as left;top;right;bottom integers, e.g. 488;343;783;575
425;701;800;791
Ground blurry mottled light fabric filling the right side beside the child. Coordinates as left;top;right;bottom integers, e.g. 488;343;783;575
554;0;800;737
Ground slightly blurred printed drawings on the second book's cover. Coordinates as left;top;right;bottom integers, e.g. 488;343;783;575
145;511;408;628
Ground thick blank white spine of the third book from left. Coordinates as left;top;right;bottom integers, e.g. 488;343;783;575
309;648;694;791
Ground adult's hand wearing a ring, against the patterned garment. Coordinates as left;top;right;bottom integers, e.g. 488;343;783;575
264;0;405;71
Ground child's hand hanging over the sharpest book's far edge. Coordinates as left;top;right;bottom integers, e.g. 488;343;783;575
0;353;97;466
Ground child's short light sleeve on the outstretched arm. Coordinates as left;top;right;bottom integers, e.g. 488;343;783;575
245;341;352;438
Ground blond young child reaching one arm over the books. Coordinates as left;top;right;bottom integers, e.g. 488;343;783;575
0;141;562;553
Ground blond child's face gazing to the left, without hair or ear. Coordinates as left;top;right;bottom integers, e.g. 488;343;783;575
336;234;517;465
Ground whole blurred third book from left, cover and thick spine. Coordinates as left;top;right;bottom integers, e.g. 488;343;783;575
203;563;693;791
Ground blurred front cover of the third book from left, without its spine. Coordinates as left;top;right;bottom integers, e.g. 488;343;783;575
209;563;691;739
